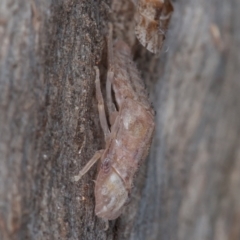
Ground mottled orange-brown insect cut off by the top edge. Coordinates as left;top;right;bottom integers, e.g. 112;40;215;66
135;0;173;53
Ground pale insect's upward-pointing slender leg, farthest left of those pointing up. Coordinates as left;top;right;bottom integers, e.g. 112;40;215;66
95;67;110;141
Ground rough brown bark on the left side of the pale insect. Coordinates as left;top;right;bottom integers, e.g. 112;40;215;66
0;0;111;239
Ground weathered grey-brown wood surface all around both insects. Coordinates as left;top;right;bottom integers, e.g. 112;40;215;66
0;0;240;240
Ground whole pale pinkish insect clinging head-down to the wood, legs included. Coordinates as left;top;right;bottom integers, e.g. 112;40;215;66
73;23;155;220
